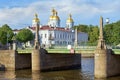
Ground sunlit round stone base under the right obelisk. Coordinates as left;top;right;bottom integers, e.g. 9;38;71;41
94;49;107;78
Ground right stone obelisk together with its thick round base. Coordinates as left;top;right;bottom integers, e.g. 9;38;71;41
94;17;107;78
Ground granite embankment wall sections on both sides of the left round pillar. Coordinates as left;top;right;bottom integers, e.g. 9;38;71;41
0;50;81;70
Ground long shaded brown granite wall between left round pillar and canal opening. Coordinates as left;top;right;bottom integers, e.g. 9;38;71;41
40;53;81;70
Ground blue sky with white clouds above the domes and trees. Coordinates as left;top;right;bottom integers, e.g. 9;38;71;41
0;0;120;29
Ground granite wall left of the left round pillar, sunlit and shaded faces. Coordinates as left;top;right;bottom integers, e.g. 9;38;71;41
0;50;31;70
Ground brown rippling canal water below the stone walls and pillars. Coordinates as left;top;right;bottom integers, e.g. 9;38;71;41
0;58;120;80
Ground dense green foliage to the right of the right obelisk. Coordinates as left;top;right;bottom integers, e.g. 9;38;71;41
104;21;120;45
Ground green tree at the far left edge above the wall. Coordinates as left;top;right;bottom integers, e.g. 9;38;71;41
0;24;14;45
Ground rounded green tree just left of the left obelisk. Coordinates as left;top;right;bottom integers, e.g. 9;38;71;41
16;29;34;43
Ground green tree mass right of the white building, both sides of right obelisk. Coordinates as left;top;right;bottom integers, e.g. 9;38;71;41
73;21;120;45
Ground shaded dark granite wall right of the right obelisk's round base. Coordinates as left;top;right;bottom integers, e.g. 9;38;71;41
107;50;120;77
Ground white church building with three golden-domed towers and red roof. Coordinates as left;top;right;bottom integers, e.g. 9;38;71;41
28;9;88;46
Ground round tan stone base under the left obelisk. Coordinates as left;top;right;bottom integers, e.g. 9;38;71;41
32;49;40;71
